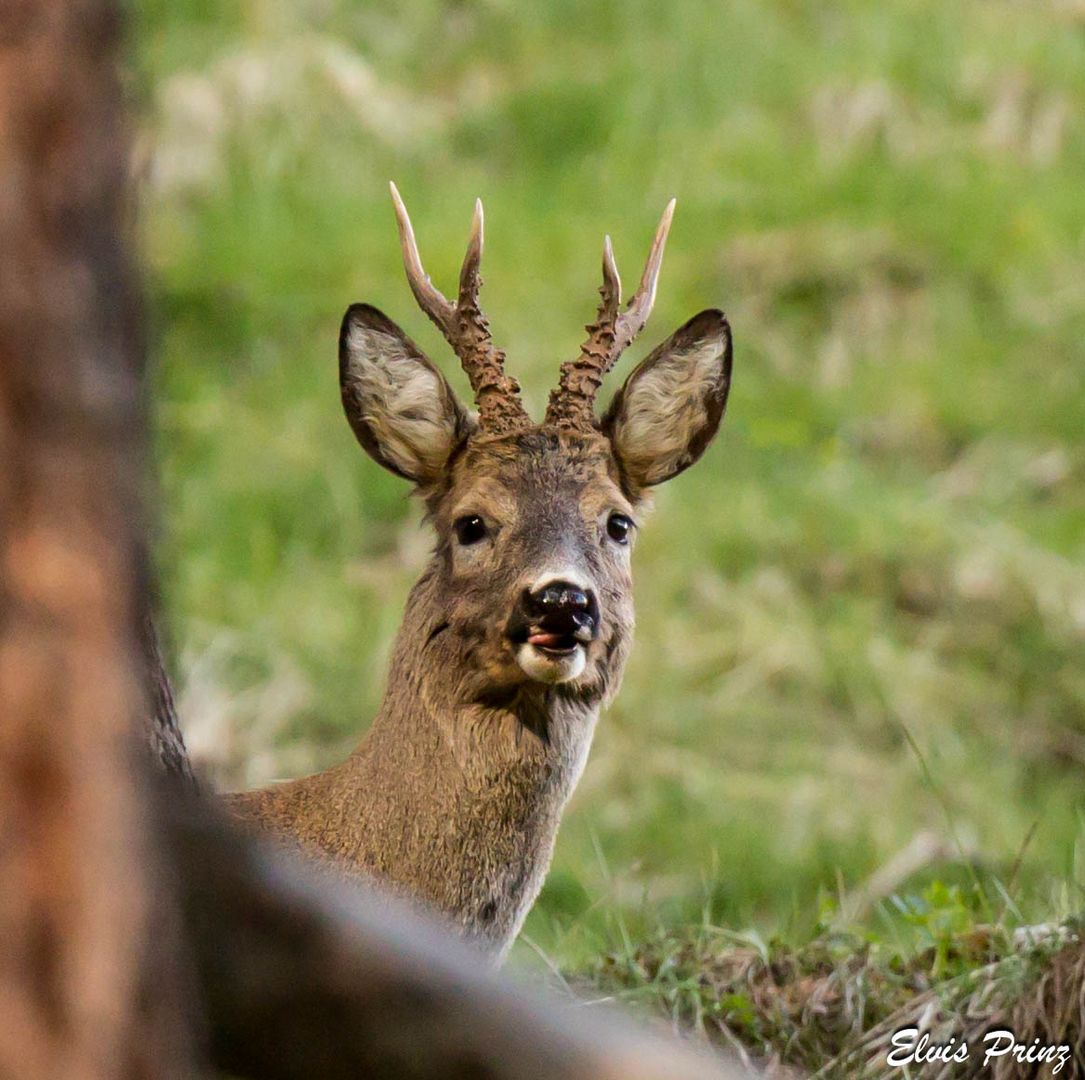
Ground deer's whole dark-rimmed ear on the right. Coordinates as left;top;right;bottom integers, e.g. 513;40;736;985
602;309;731;487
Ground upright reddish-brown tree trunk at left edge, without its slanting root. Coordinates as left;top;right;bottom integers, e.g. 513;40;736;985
0;0;190;1080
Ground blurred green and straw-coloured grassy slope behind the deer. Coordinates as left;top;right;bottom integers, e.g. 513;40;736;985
131;0;1085;968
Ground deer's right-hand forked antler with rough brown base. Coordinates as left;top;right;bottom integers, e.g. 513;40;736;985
544;199;675;429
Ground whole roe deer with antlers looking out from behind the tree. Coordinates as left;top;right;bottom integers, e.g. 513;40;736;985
229;185;731;954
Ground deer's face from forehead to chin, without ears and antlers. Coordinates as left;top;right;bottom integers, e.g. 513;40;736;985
435;428;636;695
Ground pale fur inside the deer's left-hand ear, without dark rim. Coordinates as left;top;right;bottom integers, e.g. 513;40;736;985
346;325;456;480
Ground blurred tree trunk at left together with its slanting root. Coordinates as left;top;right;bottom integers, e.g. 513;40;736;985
0;0;746;1080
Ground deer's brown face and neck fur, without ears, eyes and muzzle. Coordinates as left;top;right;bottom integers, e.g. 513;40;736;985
230;432;633;946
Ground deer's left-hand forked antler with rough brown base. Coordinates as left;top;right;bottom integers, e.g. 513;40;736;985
388;183;531;434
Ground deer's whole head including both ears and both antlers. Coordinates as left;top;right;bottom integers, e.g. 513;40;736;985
340;189;731;699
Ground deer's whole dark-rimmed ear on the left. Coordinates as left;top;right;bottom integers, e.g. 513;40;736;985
340;304;473;484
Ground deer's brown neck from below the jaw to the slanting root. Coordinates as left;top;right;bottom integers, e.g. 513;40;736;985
309;577;602;952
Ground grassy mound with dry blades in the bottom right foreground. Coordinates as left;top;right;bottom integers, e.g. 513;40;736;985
583;907;1085;1080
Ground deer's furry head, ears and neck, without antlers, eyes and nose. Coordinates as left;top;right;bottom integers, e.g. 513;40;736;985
228;240;730;953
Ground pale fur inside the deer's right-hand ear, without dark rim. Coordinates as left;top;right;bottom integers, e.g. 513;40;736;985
614;338;727;485
